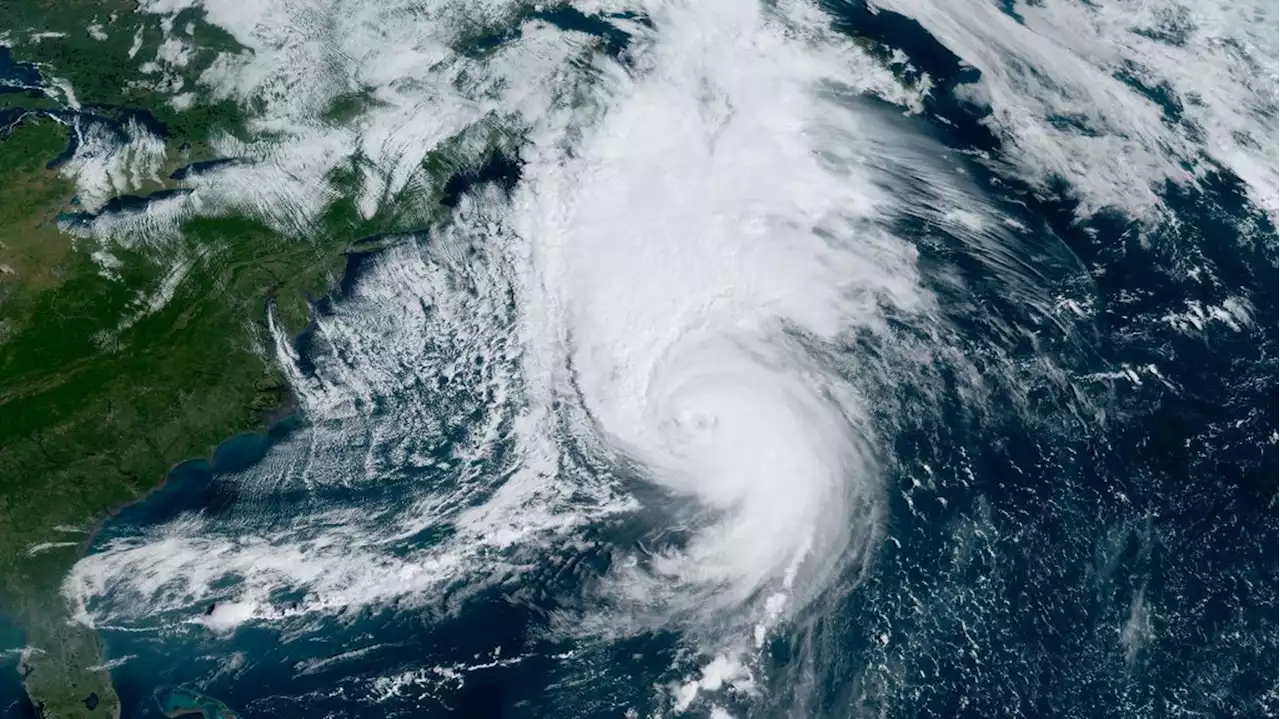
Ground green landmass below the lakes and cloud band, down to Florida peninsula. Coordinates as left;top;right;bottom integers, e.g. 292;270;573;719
0;114;338;716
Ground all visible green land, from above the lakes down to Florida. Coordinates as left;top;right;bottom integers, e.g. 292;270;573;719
0;0;483;719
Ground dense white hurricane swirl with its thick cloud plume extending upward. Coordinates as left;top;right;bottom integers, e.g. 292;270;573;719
515;3;929;637
